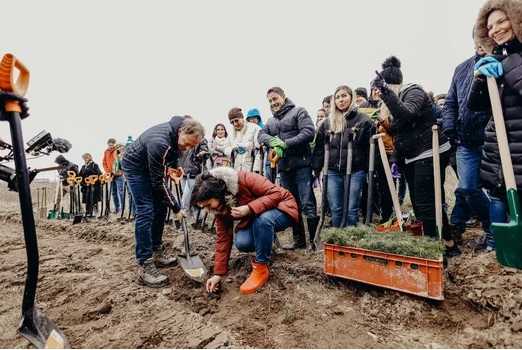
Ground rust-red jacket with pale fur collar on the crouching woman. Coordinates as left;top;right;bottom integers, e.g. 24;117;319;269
210;167;299;275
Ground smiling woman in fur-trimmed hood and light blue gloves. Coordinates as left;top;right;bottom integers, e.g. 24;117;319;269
467;0;522;250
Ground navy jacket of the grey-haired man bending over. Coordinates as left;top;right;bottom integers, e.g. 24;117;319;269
122;117;185;213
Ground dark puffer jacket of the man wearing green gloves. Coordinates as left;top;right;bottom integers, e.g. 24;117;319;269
258;98;315;172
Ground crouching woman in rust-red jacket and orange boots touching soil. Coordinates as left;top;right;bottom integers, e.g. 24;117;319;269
191;167;299;294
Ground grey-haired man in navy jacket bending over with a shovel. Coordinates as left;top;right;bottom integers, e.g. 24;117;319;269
122;116;205;287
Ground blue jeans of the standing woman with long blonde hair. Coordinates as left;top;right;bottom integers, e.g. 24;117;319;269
326;169;366;227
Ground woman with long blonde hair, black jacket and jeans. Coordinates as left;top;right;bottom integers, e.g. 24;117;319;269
313;85;372;227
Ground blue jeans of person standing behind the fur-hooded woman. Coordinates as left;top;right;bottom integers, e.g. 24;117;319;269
451;146;491;232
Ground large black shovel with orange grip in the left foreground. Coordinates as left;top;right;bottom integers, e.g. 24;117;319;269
0;53;69;349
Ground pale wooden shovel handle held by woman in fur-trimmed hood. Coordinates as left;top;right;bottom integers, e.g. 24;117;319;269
487;77;517;190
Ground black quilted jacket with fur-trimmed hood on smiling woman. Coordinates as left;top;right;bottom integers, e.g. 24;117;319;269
468;0;522;193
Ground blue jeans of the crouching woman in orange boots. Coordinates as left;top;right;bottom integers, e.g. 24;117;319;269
236;209;294;264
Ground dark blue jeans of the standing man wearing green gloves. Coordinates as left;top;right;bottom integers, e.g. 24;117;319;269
279;167;317;218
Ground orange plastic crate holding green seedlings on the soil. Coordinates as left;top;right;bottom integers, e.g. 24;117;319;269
324;243;444;300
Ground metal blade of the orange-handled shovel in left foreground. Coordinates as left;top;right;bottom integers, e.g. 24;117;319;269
18;306;69;349
